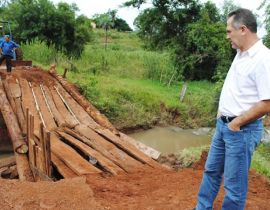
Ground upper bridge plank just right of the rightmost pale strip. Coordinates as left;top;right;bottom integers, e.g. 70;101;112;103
58;86;100;127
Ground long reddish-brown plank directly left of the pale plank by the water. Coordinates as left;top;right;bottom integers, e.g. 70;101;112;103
96;129;161;168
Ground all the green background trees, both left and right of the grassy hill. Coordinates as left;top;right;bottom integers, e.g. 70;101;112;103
0;0;270;84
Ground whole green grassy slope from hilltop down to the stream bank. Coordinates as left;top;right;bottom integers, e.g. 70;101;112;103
22;30;215;128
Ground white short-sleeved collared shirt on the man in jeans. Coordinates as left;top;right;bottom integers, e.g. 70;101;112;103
219;40;270;116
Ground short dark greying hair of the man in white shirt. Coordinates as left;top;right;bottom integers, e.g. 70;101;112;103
228;8;257;33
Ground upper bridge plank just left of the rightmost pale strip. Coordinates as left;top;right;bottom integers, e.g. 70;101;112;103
50;89;78;127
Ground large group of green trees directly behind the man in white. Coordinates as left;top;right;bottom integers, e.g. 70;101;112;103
124;0;270;81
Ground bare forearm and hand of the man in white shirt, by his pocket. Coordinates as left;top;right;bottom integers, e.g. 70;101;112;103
228;100;270;131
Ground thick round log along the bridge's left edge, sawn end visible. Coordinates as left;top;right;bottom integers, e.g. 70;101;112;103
0;80;28;154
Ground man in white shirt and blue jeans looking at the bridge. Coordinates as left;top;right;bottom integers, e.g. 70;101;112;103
196;9;270;210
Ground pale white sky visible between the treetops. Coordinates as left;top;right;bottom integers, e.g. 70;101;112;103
52;0;265;37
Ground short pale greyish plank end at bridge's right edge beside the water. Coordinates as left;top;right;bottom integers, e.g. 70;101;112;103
120;132;161;160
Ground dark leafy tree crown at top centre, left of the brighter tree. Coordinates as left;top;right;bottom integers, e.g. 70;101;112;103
135;0;201;49
